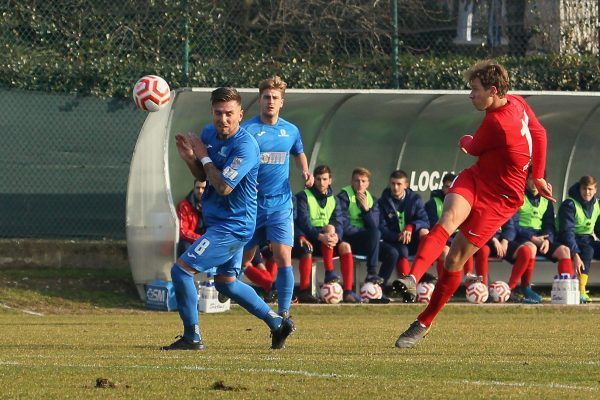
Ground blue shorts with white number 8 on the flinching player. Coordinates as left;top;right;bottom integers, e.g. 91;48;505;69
181;227;246;276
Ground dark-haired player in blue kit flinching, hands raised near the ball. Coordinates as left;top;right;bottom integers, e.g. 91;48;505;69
162;88;294;350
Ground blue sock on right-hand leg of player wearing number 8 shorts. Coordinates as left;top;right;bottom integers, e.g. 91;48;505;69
215;276;282;330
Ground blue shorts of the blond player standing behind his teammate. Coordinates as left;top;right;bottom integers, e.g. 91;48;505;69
246;208;294;249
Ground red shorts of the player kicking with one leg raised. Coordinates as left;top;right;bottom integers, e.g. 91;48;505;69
449;169;522;248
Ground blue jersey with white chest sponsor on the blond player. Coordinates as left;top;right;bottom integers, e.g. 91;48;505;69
242;115;304;212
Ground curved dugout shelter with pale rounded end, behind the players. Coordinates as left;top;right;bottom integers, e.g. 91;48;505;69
127;89;600;295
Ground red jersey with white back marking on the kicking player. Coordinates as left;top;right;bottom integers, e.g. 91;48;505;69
463;94;546;205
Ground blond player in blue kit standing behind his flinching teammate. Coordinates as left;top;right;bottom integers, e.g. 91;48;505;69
242;76;317;316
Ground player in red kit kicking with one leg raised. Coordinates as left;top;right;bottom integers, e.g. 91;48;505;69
396;60;555;348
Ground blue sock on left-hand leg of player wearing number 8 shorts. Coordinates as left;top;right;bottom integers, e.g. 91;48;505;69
171;264;200;342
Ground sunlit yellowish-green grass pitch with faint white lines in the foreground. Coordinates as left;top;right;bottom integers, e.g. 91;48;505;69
0;271;600;399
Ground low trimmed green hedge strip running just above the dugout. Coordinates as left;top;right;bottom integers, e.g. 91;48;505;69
0;51;600;97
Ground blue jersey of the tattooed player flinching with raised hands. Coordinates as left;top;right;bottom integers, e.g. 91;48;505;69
200;124;259;239
